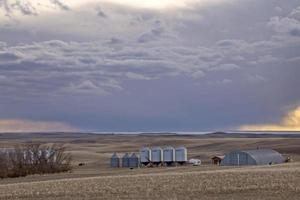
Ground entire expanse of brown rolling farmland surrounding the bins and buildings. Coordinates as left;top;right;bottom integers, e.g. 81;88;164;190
0;134;300;199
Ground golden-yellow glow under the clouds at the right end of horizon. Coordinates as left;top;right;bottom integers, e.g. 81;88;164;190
239;106;300;131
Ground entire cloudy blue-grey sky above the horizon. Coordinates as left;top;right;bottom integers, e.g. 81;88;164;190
0;0;300;132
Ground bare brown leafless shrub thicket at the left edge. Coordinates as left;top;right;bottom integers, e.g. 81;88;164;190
0;144;72;178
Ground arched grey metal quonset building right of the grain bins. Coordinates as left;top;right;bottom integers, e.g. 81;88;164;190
221;149;285;166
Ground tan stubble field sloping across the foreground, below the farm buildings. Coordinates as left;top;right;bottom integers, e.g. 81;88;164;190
0;164;300;200
